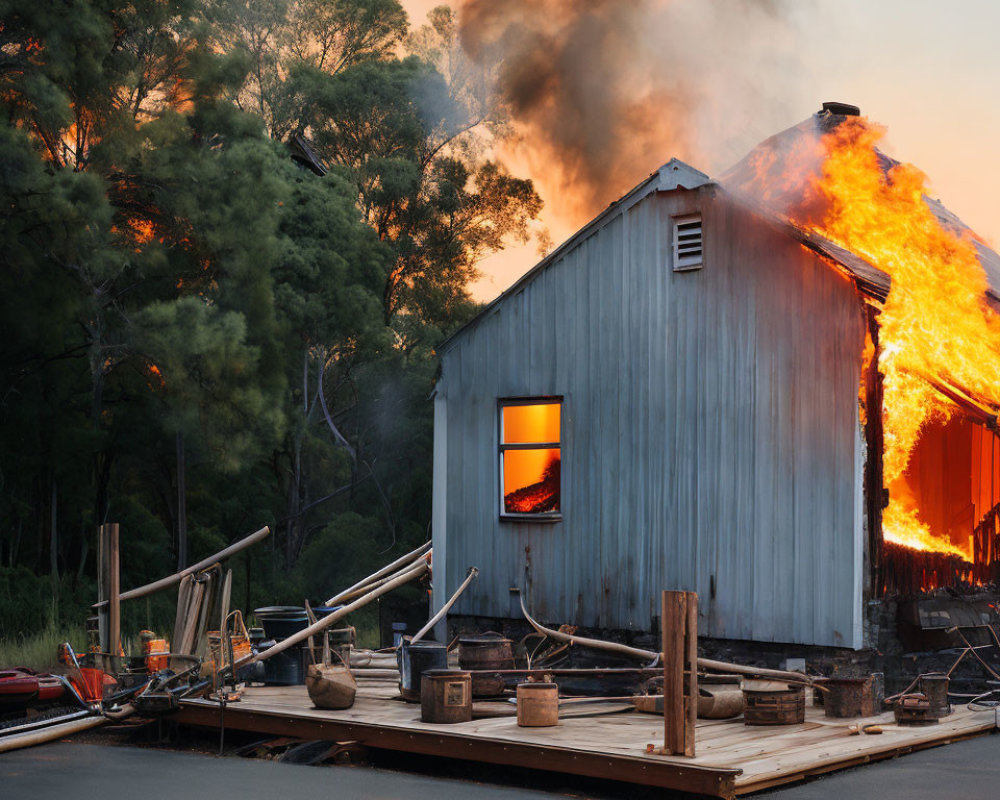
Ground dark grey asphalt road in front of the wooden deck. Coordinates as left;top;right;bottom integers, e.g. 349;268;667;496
0;736;1000;800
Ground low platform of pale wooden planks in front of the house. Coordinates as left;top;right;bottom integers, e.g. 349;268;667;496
176;680;997;798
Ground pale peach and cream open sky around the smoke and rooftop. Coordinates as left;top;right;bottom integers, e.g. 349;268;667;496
403;0;1000;300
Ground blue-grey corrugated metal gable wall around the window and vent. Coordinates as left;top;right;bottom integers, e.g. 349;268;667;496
435;185;865;647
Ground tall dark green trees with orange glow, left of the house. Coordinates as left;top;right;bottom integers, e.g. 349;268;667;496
0;0;540;644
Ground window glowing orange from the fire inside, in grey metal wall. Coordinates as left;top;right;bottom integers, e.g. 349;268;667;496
500;397;562;519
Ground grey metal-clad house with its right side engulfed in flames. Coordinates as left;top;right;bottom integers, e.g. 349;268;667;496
433;104;1000;649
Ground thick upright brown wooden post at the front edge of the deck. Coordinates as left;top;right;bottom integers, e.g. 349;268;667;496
660;592;698;756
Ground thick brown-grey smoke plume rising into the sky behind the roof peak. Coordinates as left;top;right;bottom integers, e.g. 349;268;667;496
459;0;798;222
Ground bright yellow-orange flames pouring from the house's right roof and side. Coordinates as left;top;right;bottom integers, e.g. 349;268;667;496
796;117;1000;561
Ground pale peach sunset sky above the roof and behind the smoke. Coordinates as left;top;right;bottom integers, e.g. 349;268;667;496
402;0;1000;300
